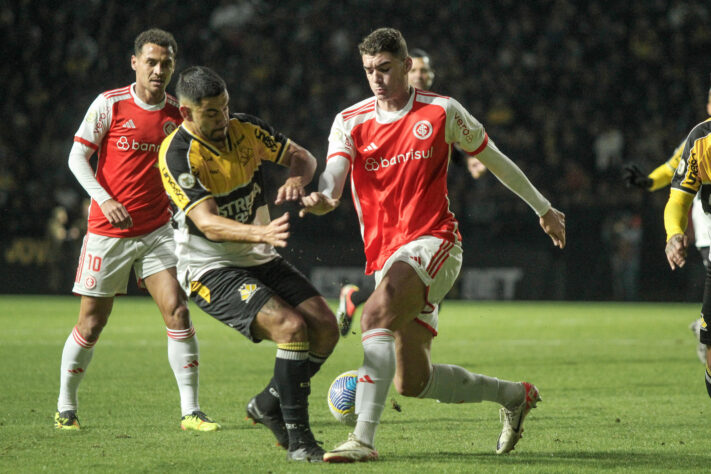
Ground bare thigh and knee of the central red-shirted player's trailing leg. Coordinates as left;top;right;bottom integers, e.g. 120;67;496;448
394;320;434;397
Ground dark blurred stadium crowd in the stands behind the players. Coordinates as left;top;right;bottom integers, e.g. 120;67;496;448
0;0;711;300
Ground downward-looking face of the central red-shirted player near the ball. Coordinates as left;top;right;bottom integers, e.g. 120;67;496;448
363;53;412;100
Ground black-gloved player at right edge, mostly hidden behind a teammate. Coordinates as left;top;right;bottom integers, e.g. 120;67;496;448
623;81;711;364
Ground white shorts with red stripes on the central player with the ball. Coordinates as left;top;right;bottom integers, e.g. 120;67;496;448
375;235;462;336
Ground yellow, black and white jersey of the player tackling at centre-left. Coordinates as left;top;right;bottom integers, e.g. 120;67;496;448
158;114;289;293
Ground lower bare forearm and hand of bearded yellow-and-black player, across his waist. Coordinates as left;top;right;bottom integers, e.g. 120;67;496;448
187;197;289;247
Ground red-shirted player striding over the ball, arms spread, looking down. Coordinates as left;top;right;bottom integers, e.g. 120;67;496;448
300;28;565;462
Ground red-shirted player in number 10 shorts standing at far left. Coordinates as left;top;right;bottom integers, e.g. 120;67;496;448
55;29;220;431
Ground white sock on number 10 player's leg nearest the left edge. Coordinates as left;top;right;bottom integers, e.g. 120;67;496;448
57;326;96;413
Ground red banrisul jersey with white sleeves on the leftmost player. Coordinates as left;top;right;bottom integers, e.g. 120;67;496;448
74;85;182;237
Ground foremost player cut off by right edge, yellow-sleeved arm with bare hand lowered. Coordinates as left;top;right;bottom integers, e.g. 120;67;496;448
664;110;711;397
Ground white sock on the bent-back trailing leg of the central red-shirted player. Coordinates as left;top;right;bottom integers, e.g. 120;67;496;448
418;364;525;409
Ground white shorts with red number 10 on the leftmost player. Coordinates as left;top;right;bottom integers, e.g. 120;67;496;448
72;224;178;297
